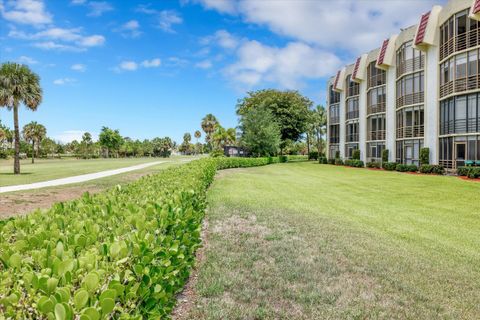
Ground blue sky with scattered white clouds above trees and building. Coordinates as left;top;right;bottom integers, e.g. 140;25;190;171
0;0;444;141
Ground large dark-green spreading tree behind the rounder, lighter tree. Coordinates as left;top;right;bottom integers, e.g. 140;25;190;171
237;89;313;151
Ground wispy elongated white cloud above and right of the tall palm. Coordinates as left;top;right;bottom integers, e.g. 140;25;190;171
8;27;105;51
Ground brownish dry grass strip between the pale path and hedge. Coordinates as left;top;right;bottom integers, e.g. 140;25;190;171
0;186;102;219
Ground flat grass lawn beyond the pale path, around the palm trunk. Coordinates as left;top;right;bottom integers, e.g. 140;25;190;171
0;157;188;186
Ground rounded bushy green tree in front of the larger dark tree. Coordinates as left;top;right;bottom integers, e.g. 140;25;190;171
240;107;281;157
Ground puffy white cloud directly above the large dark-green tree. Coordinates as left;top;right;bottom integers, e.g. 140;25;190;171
224;41;341;89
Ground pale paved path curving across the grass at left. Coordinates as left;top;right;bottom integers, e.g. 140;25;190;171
0;161;169;193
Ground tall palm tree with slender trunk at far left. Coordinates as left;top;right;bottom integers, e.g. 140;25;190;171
0;62;43;174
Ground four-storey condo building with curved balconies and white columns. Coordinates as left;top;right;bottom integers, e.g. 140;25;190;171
327;0;480;169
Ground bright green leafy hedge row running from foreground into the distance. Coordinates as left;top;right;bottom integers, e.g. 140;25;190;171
0;158;278;320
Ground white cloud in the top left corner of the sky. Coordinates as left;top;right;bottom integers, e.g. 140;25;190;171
0;0;52;27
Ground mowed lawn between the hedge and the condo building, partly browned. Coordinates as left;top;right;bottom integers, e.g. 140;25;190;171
185;162;480;319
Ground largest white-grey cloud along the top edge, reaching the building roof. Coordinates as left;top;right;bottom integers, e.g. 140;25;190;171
189;0;444;54
